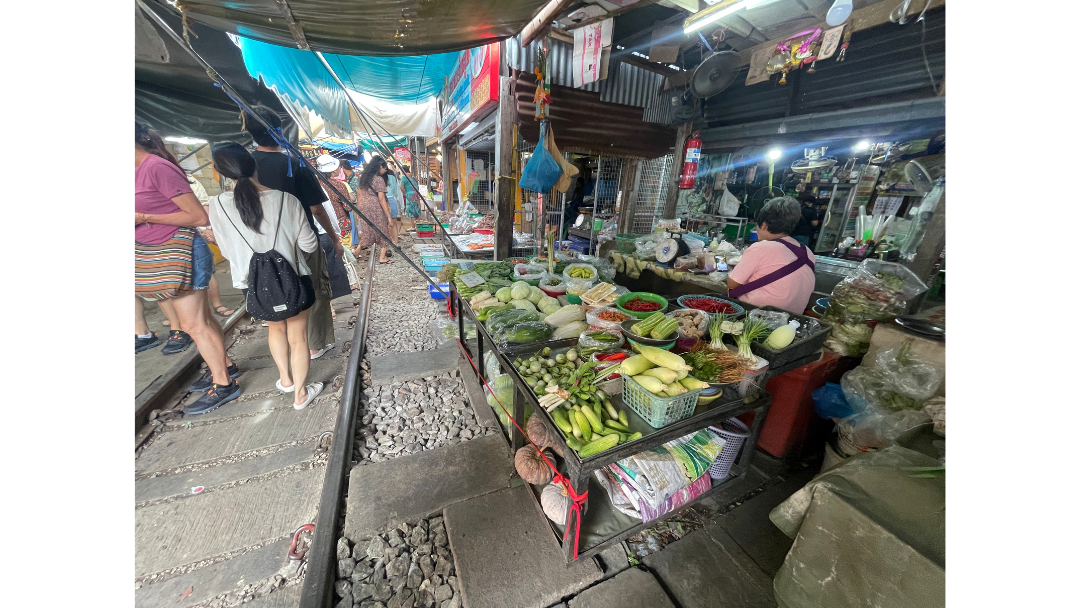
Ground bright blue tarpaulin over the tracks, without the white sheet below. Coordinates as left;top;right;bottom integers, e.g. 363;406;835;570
240;37;459;131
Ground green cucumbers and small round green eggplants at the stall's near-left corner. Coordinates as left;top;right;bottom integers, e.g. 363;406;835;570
514;348;642;458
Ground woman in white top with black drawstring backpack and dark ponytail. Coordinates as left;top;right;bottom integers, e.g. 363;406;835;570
210;141;323;409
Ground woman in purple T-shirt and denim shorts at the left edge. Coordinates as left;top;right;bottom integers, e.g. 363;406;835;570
135;122;241;414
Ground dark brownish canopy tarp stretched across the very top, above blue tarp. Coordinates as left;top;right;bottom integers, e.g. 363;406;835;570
165;0;548;55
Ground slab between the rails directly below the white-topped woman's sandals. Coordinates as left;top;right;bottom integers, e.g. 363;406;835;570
135;403;338;476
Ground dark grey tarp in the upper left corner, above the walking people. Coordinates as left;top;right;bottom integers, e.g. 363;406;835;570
135;2;283;140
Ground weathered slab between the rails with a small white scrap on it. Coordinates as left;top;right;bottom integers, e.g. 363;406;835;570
135;468;325;577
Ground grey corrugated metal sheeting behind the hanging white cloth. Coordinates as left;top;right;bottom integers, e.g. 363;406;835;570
503;37;664;108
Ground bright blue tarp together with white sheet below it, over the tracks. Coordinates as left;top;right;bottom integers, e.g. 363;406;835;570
240;37;447;137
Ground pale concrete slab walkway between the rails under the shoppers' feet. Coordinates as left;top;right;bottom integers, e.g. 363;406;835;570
134;272;359;608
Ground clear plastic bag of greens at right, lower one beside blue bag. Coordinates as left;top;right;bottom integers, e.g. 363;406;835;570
840;340;942;411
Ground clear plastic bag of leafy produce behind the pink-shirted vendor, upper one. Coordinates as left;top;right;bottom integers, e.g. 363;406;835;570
822;259;927;325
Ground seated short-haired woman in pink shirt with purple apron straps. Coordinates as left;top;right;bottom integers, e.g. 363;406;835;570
728;197;815;314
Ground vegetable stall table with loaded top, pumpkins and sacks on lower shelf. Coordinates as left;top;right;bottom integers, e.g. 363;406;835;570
440;250;828;562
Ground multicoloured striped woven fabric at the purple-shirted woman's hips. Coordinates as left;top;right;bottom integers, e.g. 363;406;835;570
135;228;195;301
